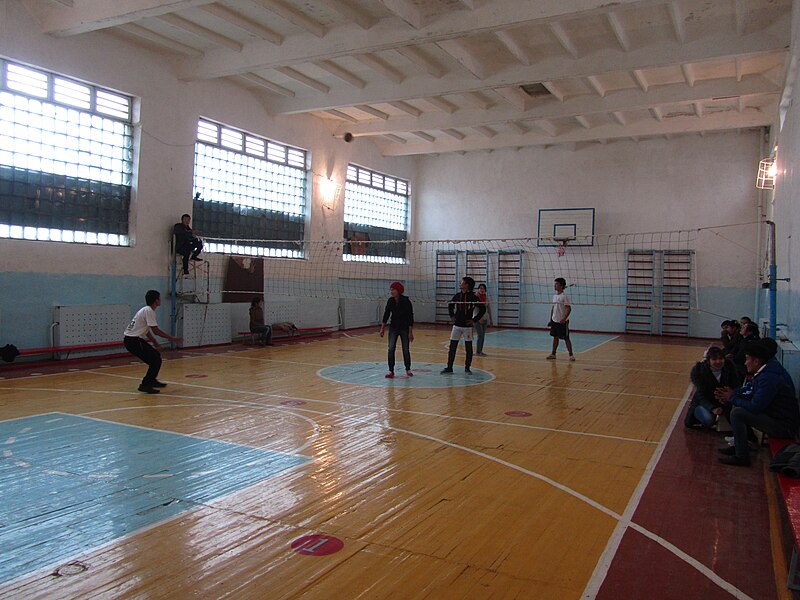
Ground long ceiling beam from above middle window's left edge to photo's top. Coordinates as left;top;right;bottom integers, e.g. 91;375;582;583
178;0;658;79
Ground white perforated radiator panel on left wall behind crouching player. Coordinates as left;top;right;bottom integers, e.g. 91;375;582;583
53;304;132;359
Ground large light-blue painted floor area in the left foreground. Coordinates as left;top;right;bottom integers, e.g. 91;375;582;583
0;413;310;581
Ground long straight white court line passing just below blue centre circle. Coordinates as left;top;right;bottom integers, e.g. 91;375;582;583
90;372;660;444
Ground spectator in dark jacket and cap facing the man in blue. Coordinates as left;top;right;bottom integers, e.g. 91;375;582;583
683;346;742;429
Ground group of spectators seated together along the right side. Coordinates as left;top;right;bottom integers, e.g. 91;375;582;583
684;317;800;466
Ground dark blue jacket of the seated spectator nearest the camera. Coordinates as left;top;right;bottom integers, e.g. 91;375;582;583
730;358;800;429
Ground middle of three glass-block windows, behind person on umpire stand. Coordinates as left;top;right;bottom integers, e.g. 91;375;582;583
192;119;307;258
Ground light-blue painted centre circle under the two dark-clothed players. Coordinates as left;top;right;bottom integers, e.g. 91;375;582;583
317;360;494;388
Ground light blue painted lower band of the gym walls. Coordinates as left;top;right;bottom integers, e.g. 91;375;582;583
0;273;768;348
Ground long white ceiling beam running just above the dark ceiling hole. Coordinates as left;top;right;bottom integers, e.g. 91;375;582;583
260;20;790;114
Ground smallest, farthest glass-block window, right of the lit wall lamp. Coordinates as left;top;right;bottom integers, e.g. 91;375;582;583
343;165;409;263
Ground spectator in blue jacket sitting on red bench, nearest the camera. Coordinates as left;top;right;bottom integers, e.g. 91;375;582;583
715;338;800;466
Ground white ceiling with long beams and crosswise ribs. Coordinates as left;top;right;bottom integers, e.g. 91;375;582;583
22;0;792;155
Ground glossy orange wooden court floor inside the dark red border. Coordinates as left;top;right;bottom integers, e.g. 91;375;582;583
0;328;780;600
